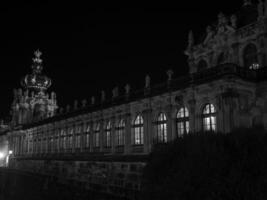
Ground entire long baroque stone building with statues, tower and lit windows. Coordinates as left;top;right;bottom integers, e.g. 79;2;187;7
5;0;267;198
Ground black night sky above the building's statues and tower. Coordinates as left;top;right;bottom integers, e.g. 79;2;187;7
0;0;245;117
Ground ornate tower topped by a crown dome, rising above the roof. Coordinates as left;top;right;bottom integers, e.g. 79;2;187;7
12;50;57;125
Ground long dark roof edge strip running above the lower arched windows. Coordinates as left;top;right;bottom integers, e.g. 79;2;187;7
19;63;267;129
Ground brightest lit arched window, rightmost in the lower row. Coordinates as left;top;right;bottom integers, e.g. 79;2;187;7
202;104;216;131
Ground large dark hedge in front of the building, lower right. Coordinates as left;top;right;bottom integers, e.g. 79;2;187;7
142;128;267;200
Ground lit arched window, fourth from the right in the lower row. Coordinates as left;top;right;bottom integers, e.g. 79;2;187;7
132;115;144;145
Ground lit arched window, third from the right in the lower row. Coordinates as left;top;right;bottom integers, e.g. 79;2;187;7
157;113;167;142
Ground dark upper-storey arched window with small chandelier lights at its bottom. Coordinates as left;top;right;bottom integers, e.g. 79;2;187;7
243;44;259;69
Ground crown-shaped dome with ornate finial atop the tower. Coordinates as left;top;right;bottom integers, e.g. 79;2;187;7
21;50;51;92
